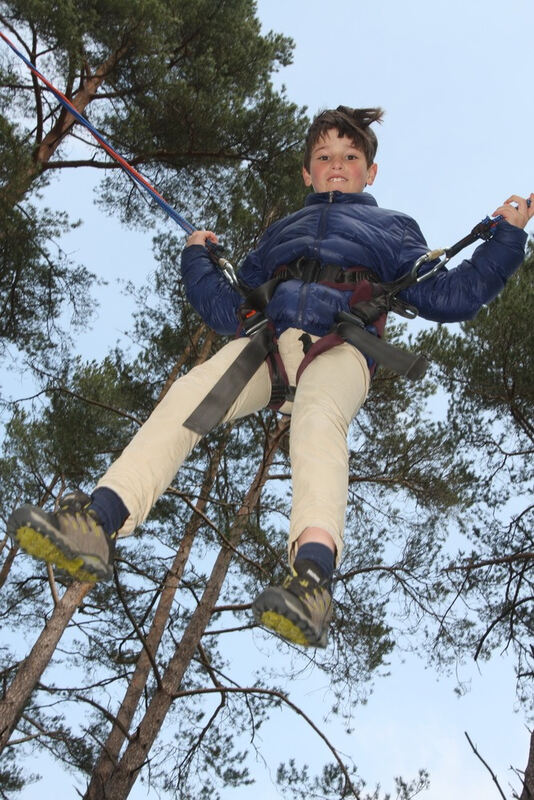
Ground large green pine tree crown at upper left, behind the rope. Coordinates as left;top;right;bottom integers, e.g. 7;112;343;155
0;0;305;356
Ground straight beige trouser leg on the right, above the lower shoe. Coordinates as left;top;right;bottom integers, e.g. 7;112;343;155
289;343;370;563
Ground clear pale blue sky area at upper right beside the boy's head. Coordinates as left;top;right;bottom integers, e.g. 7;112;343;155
258;0;534;245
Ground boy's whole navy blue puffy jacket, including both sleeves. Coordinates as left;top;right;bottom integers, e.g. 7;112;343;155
182;192;527;336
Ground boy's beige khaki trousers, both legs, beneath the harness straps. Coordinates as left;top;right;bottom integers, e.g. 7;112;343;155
98;328;369;563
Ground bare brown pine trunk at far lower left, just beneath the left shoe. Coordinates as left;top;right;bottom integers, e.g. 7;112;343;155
0;583;93;752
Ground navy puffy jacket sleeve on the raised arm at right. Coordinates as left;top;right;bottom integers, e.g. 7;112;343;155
400;220;527;322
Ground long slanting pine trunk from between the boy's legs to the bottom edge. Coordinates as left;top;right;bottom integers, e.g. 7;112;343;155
94;420;289;800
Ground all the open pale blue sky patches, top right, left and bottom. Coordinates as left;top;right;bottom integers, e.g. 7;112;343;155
5;0;534;800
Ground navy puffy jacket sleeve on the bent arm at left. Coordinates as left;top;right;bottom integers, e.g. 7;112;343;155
182;244;242;336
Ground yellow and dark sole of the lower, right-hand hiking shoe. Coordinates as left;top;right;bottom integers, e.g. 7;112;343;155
253;589;327;647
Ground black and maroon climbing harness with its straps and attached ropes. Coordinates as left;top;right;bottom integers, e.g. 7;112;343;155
0;31;530;435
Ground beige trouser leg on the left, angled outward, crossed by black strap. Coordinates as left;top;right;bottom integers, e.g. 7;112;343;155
98;339;271;536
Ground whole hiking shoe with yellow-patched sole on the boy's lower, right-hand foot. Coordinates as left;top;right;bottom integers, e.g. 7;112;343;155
252;560;332;647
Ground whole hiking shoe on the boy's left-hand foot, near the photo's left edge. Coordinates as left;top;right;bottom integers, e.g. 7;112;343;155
7;491;114;583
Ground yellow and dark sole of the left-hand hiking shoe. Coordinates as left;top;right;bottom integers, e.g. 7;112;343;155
10;506;112;583
